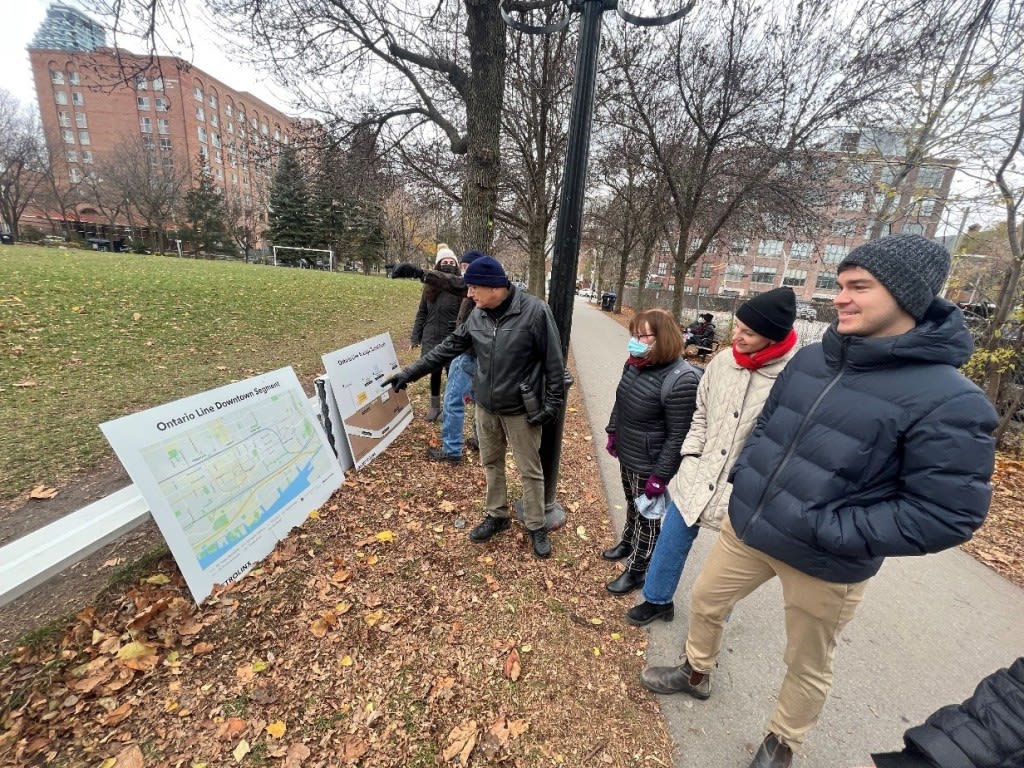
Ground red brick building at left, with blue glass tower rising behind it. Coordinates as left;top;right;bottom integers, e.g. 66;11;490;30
29;4;300;243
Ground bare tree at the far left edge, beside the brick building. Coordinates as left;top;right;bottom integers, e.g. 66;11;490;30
0;89;46;240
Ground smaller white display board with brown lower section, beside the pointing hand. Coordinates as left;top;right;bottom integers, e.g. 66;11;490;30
324;333;413;469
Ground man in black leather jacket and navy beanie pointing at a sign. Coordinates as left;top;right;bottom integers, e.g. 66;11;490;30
382;255;565;557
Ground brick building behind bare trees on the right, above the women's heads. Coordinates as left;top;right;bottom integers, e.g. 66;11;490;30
646;132;956;302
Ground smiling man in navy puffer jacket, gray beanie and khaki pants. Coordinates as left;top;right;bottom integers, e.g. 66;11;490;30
641;234;996;768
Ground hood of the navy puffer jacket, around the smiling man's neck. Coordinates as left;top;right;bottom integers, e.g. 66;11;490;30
821;298;974;368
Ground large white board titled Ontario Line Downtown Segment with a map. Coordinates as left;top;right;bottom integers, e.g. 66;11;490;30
100;368;344;601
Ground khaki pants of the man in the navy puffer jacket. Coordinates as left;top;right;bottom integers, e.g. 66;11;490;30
686;517;867;750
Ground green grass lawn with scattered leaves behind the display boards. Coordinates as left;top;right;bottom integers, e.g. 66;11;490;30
0;246;421;501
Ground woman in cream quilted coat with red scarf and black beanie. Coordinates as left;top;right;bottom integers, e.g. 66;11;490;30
626;288;797;627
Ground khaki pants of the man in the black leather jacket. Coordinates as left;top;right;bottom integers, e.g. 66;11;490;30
476;407;545;530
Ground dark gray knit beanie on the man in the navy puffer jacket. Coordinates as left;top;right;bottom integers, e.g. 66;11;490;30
837;234;950;321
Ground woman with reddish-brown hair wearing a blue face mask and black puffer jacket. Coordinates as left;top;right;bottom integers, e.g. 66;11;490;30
602;309;698;595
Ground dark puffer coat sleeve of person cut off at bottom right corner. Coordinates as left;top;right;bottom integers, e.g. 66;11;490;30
871;656;1024;768
